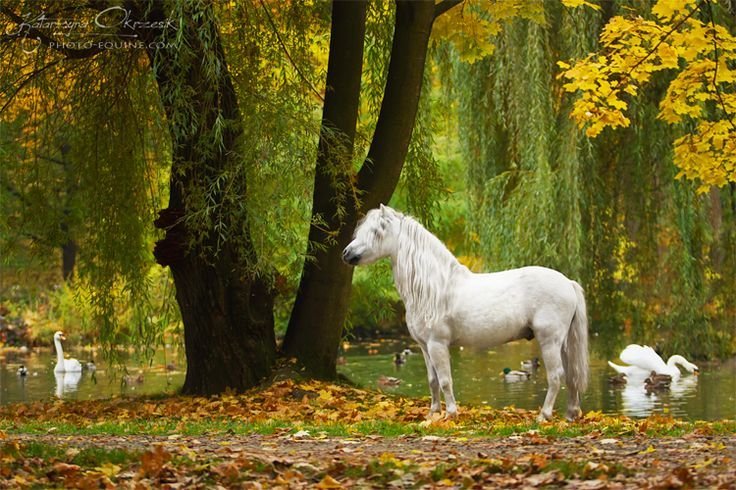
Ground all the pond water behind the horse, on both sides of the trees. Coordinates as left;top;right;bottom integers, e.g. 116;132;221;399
0;340;736;420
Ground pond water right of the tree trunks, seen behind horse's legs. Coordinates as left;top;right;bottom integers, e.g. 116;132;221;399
338;341;736;420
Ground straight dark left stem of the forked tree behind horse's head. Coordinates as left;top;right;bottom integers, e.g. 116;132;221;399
283;1;367;378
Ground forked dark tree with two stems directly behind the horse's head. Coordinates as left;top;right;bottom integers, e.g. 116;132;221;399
284;1;440;377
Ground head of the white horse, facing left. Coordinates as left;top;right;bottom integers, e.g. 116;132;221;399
342;204;403;265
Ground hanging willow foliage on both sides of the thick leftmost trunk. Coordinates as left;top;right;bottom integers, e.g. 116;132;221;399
0;0;329;357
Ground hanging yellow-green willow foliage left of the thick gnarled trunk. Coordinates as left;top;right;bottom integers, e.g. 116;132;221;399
0;15;170;366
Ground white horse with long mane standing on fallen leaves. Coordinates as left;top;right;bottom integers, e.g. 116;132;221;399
343;205;588;421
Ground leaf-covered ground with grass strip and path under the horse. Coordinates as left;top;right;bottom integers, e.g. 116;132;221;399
0;381;736;488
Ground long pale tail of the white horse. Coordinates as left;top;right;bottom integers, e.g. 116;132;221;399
564;281;588;393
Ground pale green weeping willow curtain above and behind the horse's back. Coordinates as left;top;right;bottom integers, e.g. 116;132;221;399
453;1;736;358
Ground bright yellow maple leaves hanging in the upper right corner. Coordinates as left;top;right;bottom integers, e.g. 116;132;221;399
558;0;736;192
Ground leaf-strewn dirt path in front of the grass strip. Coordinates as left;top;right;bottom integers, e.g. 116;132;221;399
5;432;736;488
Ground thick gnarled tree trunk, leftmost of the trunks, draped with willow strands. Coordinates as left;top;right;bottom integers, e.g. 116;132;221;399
139;2;276;394
